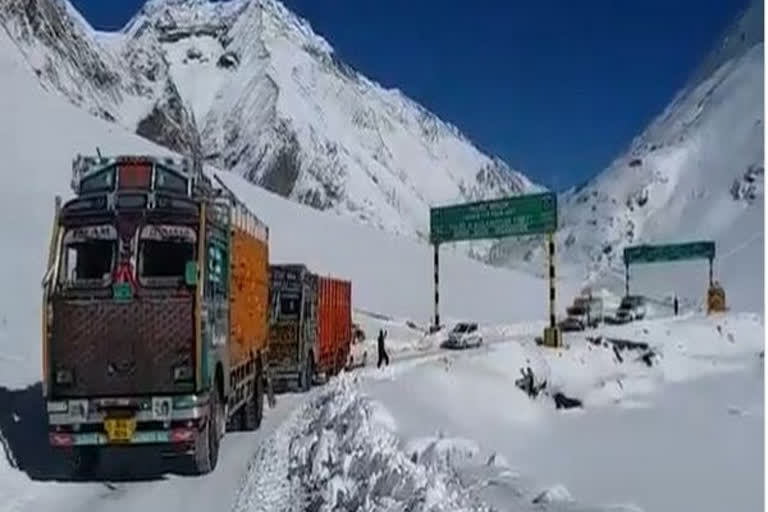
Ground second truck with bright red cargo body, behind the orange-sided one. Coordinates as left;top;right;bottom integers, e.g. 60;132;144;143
269;264;352;391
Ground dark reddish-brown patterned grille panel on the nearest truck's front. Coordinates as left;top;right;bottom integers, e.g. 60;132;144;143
51;297;195;396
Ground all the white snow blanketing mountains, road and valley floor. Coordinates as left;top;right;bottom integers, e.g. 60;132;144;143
0;0;764;512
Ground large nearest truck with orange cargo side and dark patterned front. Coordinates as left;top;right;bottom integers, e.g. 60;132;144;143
42;155;274;475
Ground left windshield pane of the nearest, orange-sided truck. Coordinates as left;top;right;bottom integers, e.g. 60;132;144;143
59;225;117;286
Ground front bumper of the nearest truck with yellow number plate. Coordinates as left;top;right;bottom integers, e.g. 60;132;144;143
47;395;209;448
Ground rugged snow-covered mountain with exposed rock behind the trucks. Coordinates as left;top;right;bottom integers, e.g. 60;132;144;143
0;0;539;237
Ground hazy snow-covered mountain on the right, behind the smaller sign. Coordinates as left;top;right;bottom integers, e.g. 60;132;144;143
491;1;764;310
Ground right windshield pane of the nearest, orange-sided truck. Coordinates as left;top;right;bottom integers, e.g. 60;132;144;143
138;225;196;284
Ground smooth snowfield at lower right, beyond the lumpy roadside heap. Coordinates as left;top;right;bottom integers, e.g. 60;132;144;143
361;314;764;512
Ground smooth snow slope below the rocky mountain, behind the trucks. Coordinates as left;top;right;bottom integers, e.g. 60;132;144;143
0;25;568;387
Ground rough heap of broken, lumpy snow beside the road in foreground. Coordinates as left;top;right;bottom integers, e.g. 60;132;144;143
233;377;484;512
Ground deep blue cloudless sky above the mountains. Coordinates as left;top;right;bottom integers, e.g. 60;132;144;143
73;0;748;190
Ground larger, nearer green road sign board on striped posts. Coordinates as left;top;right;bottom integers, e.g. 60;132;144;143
429;192;557;244
